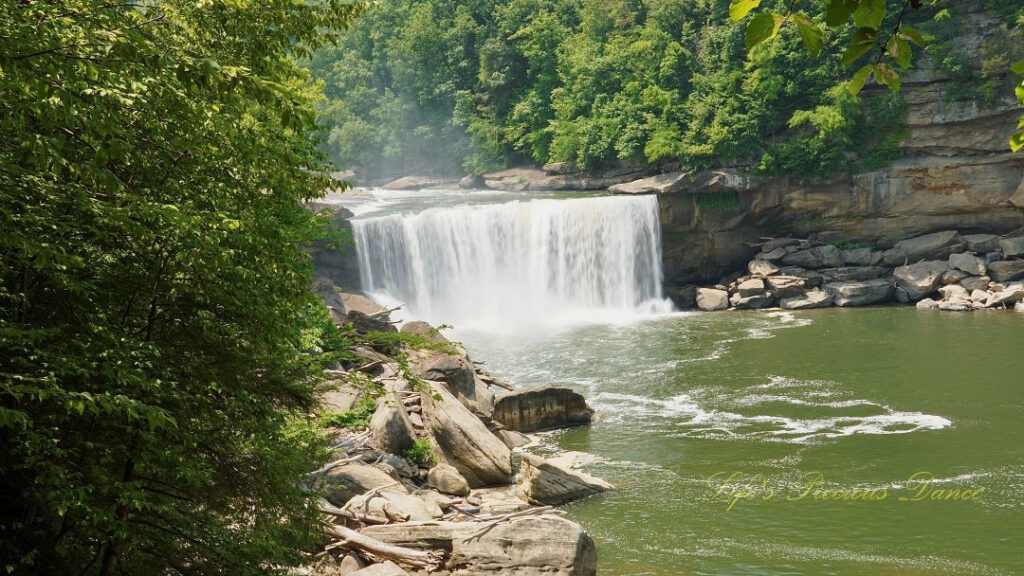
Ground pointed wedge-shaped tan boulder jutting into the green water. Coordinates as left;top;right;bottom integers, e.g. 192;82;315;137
516;454;614;506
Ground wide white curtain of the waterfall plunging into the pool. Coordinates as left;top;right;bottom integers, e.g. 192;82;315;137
352;196;671;327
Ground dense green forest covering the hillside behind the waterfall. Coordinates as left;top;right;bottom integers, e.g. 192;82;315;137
309;0;1021;177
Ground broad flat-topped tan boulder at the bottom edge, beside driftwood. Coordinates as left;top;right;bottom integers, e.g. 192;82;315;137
360;515;597;576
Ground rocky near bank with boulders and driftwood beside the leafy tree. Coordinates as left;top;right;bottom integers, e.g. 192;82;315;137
307;289;612;576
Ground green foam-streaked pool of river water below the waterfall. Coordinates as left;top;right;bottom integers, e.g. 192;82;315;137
456;307;1024;576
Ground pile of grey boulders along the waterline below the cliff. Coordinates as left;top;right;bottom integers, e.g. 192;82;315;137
679;231;1024;312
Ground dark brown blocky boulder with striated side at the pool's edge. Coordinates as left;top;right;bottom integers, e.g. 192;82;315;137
493;385;594;433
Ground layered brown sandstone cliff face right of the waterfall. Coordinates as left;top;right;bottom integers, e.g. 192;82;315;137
660;2;1024;284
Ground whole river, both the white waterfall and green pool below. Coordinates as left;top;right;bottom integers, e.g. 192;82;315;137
327;191;1024;576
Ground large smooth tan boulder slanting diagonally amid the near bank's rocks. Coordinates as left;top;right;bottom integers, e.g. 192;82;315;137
420;382;512;488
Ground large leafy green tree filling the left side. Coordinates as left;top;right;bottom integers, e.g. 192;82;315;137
0;0;359;575
